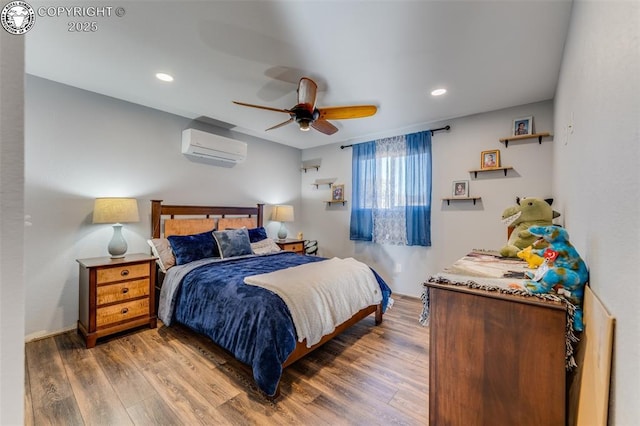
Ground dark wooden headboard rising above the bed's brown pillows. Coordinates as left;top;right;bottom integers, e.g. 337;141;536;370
151;200;264;238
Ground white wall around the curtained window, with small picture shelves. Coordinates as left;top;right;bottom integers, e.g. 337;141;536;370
299;101;555;296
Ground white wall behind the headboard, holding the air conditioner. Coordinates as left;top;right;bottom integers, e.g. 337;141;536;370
25;76;300;340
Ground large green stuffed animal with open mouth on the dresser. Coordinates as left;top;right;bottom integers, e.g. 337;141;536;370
500;197;560;257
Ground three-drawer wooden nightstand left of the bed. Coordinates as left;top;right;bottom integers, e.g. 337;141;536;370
77;254;157;348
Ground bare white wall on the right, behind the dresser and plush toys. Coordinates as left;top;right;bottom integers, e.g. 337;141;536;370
553;0;640;425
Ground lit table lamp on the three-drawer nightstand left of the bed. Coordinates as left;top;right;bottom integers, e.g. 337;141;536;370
93;198;140;259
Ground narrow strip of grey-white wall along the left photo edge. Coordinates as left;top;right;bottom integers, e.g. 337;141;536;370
0;31;25;425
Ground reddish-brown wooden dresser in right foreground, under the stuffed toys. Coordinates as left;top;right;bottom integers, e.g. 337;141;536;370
426;283;566;426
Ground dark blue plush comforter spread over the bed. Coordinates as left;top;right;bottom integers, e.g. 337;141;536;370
161;252;391;396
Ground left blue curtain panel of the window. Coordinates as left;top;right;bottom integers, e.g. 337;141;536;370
350;141;376;241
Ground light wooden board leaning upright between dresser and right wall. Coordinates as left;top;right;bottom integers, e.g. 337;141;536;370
569;286;615;426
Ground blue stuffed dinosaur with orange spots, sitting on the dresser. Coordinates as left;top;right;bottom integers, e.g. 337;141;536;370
525;225;589;331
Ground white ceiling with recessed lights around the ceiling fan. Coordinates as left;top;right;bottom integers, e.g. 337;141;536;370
26;0;571;149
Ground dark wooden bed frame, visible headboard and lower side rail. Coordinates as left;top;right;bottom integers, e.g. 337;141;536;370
151;200;382;367
